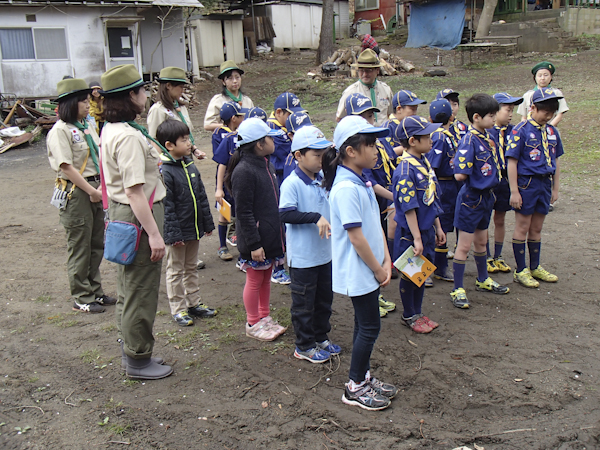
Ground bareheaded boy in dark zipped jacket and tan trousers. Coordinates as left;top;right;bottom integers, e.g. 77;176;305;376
156;120;216;326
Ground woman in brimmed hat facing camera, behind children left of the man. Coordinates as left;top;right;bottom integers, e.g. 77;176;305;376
204;61;254;131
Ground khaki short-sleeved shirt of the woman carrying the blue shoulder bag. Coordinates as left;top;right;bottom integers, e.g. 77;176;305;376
101;122;166;205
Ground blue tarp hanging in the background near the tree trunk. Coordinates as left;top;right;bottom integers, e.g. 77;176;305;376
406;0;467;50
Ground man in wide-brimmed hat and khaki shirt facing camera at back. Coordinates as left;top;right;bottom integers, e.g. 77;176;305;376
336;48;394;127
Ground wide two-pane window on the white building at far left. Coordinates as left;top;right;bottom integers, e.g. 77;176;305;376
0;28;69;60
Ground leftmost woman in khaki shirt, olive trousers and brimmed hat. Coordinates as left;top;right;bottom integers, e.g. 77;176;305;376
46;78;116;313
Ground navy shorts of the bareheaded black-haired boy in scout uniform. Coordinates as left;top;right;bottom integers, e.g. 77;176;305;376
454;186;496;233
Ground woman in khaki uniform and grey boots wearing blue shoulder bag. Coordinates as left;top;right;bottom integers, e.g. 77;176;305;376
101;64;173;380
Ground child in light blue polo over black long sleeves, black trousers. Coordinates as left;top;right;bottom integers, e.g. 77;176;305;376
279;126;341;363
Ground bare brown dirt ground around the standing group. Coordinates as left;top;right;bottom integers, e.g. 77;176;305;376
0;43;600;450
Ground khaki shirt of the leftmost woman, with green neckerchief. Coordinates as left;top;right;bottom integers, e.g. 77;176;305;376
46;120;100;180
